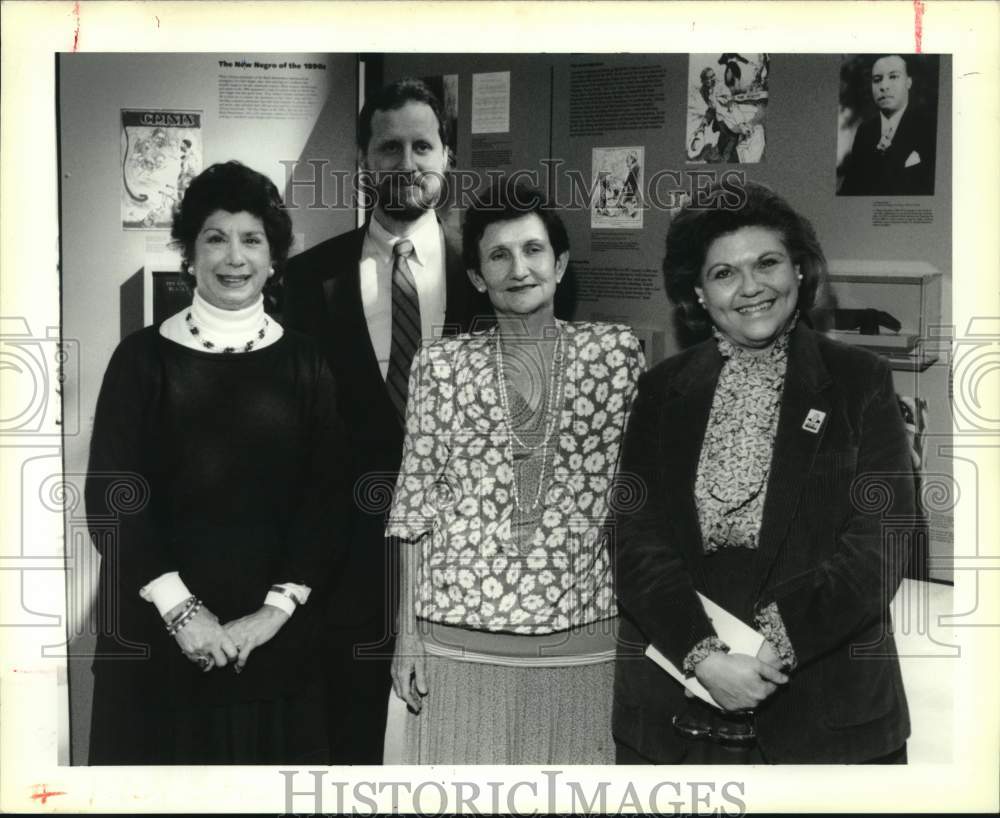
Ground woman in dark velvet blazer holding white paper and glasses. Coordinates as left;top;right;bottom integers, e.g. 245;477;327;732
614;183;919;763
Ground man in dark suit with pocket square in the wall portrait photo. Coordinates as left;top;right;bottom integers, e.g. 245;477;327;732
838;54;937;196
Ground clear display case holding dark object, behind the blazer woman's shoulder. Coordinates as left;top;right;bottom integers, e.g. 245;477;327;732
825;259;942;371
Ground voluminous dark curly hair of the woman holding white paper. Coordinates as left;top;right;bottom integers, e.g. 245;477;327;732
663;182;827;340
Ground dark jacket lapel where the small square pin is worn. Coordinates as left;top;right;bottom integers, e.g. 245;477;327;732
753;326;831;598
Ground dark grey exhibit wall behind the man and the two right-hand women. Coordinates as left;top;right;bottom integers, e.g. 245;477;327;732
381;54;952;581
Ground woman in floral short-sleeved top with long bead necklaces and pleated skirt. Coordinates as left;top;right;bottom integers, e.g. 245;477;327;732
386;180;643;764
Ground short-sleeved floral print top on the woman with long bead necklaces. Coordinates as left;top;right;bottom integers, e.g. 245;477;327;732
386;322;645;634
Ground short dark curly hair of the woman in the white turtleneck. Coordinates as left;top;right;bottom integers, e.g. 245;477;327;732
170;161;292;280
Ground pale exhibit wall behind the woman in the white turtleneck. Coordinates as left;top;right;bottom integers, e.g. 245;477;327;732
59;54;357;484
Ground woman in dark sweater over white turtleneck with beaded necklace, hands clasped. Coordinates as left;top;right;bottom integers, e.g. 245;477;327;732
86;162;349;764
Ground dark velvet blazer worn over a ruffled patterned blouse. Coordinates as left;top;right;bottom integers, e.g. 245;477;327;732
614;324;920;763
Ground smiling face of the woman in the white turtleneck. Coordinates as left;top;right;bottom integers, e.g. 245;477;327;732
191;210;272;310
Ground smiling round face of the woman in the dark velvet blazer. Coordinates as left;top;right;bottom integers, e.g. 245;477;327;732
695;227;800;349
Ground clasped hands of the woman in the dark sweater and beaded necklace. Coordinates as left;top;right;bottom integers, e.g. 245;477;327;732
168;605;288;673
